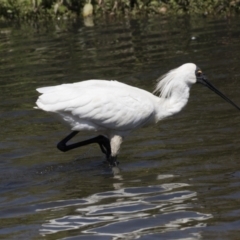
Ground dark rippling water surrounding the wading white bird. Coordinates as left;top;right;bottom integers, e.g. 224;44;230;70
0;17;240;240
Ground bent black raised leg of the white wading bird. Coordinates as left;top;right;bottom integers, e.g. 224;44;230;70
57;131;111;159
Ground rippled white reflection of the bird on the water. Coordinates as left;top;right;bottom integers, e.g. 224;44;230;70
37;175;212;239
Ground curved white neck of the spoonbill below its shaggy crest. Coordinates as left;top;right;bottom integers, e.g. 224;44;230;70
158;86;190;121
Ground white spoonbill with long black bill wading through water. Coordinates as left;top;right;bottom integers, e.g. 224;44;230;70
35;63;240;166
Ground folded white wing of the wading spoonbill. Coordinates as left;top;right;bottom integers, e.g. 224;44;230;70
36;80;154;131
